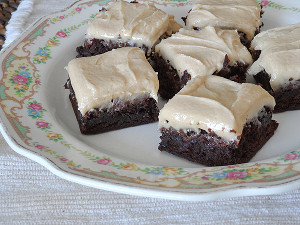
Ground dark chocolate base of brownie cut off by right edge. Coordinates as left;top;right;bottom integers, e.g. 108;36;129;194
254;70;300;113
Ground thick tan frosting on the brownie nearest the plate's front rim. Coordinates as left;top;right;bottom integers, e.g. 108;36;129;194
159;75;275;141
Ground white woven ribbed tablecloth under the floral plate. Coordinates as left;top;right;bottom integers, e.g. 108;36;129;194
0;0;300;225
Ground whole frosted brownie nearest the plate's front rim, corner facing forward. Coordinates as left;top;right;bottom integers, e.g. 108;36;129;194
159;76;278;166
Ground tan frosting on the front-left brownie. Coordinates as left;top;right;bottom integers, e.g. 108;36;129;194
66;47;159;115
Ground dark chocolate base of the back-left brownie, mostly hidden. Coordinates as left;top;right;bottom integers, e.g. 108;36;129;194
76;38;148;58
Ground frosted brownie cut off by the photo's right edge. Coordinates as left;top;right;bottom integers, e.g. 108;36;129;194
248;23;300;112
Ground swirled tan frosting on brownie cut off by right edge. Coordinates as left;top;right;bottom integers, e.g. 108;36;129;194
248;23;300;90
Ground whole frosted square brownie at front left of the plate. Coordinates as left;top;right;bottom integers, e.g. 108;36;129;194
65;47;159;134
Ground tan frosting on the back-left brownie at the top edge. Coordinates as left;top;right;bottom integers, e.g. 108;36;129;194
86;1;181;55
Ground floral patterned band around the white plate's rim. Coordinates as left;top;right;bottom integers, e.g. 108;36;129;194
0;0;300;200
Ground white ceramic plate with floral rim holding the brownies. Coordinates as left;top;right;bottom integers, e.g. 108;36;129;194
0;0;300;201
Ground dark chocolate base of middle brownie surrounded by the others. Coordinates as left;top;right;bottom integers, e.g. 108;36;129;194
152;53;248;99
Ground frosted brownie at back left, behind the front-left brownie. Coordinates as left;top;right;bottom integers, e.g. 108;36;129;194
76;1;181;57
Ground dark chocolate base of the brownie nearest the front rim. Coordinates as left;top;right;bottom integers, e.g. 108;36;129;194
158;107;278;166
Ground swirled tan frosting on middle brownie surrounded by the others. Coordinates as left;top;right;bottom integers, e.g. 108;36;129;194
155;27;253;78
